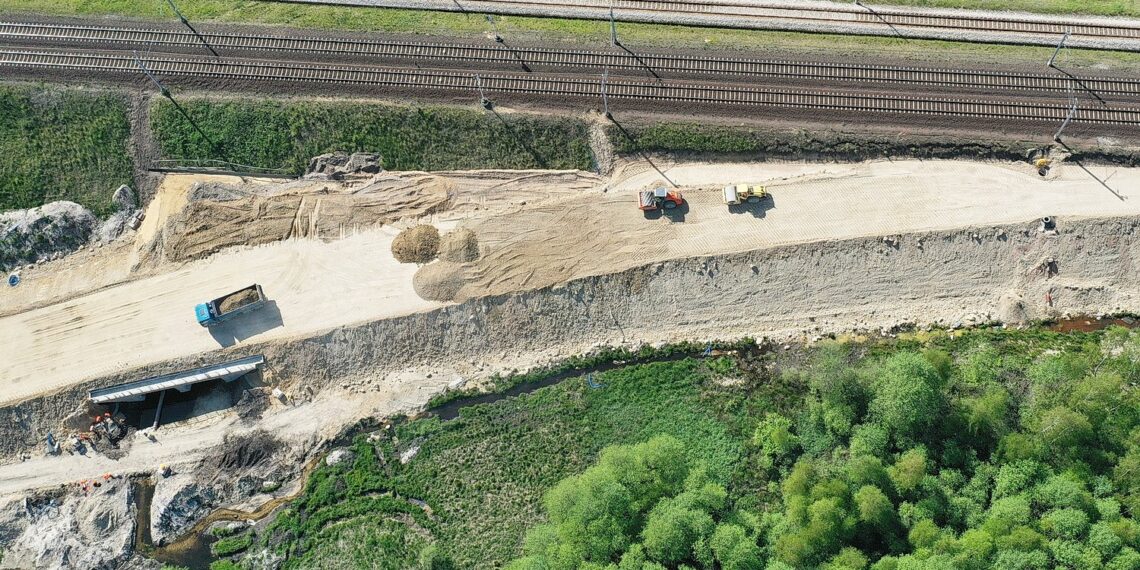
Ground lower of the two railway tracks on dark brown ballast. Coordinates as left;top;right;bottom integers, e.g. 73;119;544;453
8;50;1140;127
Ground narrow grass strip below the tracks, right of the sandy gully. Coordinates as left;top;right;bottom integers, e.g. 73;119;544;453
608;122;1140;166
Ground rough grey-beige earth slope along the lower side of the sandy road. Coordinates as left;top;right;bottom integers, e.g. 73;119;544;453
0;218;1140;457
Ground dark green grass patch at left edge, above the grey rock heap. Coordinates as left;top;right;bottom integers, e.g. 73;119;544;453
0;84;132;217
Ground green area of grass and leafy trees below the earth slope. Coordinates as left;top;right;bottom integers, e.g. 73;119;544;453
215;329;1140;570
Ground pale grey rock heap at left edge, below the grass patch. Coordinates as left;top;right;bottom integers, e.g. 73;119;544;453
0;202;99;271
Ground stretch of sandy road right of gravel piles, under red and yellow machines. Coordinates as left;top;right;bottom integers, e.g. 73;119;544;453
458;161;1140;299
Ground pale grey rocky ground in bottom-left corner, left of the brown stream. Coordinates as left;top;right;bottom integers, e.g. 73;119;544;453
0;478;135;570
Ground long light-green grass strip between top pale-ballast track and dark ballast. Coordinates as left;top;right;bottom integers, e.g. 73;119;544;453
0;0;1140;68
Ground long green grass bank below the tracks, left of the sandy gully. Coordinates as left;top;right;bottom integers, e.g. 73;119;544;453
152;99;593;174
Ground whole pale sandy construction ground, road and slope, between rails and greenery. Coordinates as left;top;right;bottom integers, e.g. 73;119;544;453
0;160;1140;503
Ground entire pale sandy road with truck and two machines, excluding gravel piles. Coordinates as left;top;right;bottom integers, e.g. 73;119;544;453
0;161;1140;404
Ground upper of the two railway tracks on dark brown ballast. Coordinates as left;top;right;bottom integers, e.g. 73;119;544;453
0;22;1140;97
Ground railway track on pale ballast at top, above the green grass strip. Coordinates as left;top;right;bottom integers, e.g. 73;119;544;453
269;0;1140;50
